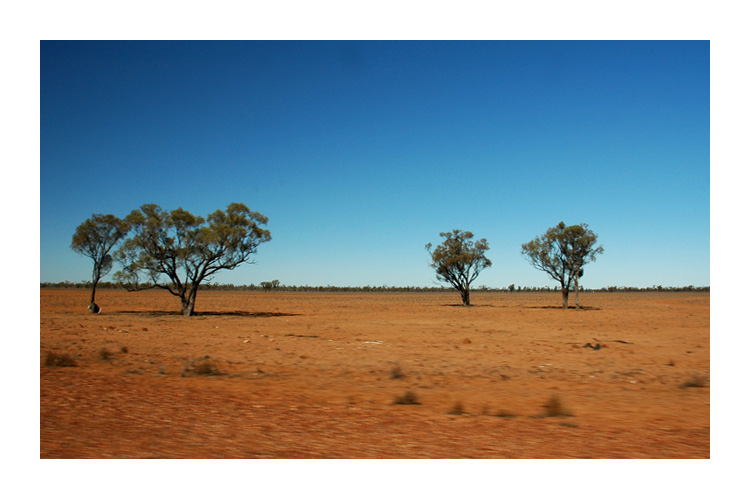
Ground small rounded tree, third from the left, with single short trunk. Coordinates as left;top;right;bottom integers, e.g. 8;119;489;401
425;229;492;305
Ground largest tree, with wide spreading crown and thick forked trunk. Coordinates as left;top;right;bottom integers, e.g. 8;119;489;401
117;203;271;316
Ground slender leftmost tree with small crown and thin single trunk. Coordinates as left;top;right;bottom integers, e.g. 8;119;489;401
70;214;128;313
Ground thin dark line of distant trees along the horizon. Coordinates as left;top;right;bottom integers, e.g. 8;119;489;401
40;281;711;293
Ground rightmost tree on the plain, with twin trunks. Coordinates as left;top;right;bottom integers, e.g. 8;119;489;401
521;222;604;309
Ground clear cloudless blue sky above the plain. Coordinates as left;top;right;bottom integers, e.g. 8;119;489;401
40;41;710;287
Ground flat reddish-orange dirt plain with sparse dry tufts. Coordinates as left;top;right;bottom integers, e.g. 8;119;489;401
40;289;710;458
